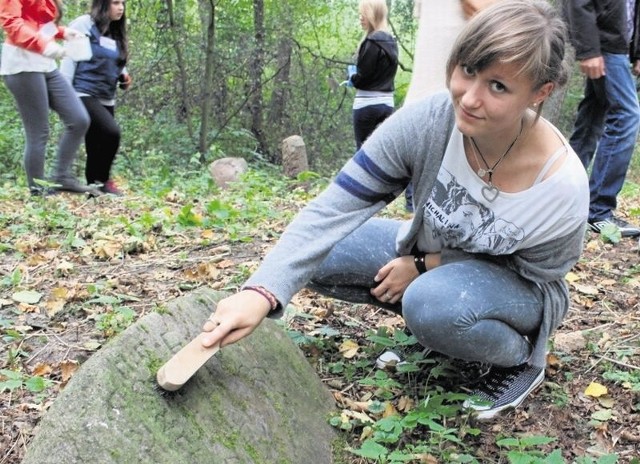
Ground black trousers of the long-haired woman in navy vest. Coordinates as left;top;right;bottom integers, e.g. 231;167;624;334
81;97;120;184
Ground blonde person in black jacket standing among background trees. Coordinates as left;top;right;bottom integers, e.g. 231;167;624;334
349;0;398;150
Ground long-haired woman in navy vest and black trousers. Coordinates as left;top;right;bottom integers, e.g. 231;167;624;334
61;0;131;195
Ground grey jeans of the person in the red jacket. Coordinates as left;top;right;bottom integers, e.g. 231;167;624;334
4;69;89;187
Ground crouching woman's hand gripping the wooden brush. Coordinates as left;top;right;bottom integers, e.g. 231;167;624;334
202;290;271;347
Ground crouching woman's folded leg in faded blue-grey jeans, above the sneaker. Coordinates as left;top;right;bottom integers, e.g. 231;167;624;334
402;259;543;367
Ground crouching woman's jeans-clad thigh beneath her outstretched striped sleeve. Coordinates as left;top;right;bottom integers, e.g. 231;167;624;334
307;218;402;313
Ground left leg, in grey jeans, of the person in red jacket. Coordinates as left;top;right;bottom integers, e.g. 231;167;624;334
4;72;49;189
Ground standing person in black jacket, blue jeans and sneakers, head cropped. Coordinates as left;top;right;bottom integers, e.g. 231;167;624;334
563;0;640;237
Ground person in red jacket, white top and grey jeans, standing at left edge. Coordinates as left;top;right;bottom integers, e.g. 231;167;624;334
0;0;93;195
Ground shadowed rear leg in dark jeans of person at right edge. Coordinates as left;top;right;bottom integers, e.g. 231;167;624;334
569;78;608;169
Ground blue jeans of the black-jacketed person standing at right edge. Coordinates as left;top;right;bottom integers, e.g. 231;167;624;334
569;53;640;222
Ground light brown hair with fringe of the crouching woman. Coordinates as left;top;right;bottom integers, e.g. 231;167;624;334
447;0;569;114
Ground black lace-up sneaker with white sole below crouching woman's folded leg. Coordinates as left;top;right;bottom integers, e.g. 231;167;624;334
463;364;544;420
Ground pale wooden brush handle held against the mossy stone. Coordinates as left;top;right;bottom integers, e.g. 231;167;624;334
156;332;220;391
